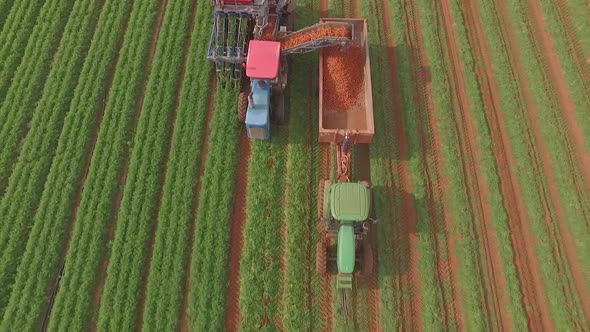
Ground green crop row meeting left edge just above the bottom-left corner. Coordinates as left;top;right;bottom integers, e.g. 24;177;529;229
0;0;101;314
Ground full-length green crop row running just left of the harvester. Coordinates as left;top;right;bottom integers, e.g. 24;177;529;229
143;1;212;331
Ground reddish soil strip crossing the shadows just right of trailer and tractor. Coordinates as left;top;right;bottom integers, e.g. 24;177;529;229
382;0;422;331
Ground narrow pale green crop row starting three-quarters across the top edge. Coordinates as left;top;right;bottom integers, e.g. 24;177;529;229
450;0;527;330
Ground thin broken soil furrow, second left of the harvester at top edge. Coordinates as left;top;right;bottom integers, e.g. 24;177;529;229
90;0;168;331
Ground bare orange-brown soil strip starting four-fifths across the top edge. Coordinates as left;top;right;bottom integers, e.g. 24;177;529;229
462;0;553;331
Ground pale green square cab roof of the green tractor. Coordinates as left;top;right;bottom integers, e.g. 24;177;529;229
330;182;371;221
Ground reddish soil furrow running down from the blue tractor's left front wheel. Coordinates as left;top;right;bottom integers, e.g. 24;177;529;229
225;131;250;331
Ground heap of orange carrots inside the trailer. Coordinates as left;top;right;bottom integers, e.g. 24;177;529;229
323;47;365;111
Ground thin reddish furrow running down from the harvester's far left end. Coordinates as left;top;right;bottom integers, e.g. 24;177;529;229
180;81;217;331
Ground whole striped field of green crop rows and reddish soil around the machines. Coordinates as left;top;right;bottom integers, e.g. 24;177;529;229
0;0;590;331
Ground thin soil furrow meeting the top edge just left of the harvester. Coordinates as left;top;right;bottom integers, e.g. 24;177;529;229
138;2;197;331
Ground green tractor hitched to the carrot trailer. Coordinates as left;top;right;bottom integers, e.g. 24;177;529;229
316;180;375;290
